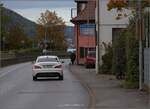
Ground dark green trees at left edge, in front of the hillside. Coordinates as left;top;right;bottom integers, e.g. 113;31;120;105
0;4;31;51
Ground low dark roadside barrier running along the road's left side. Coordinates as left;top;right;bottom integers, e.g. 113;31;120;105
0;51;69;67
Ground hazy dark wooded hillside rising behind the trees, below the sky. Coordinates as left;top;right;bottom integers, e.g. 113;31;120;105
1;7;74;46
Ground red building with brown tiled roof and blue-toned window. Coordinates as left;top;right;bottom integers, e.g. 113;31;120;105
71;0;96;64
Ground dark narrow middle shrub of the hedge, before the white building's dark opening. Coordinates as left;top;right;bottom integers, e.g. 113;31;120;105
112;30;126;79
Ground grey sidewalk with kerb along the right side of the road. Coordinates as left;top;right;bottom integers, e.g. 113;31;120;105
70;65;150;109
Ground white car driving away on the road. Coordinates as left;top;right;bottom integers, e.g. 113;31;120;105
32;56;63;81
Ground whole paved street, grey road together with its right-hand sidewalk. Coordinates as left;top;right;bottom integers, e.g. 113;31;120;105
0;60;149;109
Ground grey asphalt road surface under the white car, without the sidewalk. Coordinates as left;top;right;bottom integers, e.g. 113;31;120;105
0;60;89;109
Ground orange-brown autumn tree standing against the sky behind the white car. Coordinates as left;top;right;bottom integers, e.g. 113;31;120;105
37;10;67;50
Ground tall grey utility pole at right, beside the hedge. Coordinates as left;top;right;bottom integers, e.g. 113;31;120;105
136;0;143;90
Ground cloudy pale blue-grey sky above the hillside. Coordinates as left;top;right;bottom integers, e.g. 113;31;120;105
1;0;76;25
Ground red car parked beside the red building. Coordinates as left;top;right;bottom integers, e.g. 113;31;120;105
85;51;96;68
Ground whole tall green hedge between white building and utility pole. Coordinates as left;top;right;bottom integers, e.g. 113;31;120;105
100;19;139;88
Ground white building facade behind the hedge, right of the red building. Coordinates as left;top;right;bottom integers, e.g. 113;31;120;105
96;0;131;69
